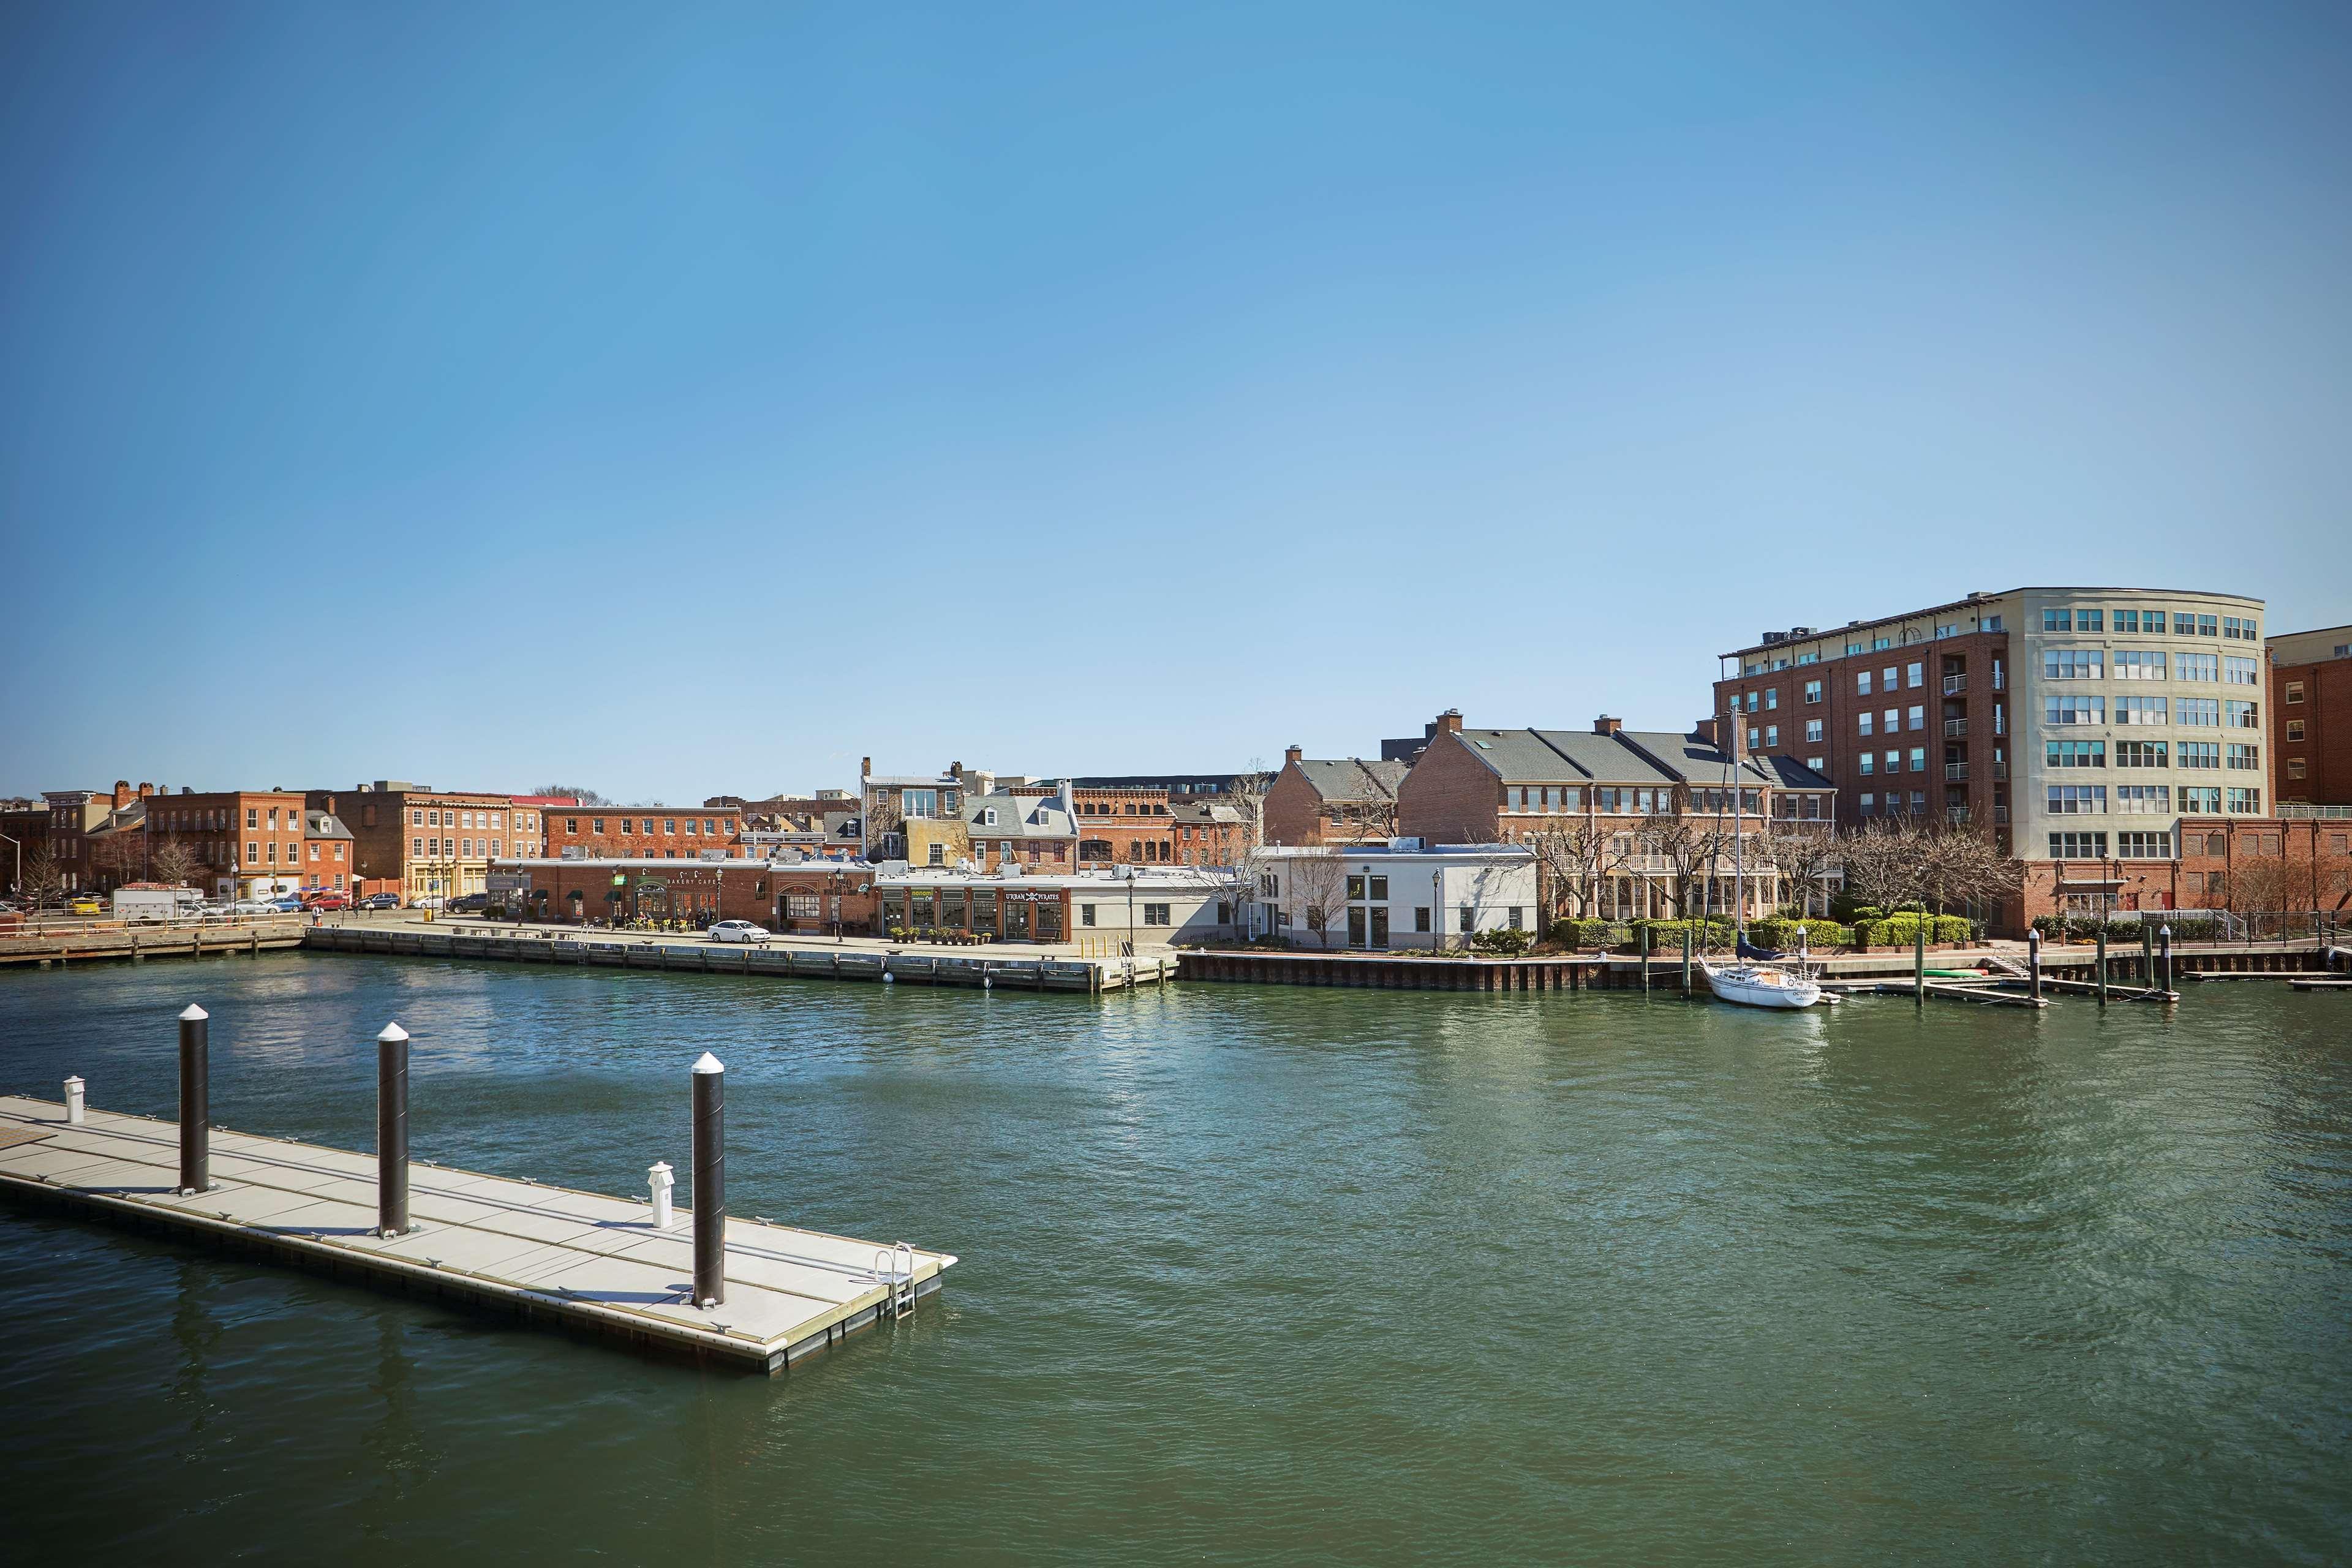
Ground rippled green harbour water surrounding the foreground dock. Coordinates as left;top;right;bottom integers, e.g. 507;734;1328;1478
0;954;2352;1563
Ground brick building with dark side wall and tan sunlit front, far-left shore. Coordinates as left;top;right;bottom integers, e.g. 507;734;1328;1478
334;778;543;903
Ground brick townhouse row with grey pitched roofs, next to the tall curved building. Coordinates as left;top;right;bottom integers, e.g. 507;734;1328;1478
1397;715;1837;919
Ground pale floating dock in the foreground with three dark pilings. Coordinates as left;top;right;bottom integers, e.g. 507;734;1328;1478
0;1096;955;1373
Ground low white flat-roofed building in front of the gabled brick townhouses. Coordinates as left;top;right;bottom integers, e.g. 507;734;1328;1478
1249;839;1540;952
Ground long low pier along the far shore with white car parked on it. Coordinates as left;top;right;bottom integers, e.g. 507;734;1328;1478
301;926;1176;992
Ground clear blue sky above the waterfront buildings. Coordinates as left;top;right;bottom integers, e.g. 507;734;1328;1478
0;5;2352;802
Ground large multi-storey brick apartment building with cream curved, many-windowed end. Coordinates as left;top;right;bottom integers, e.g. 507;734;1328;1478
1714;588;2274;929
